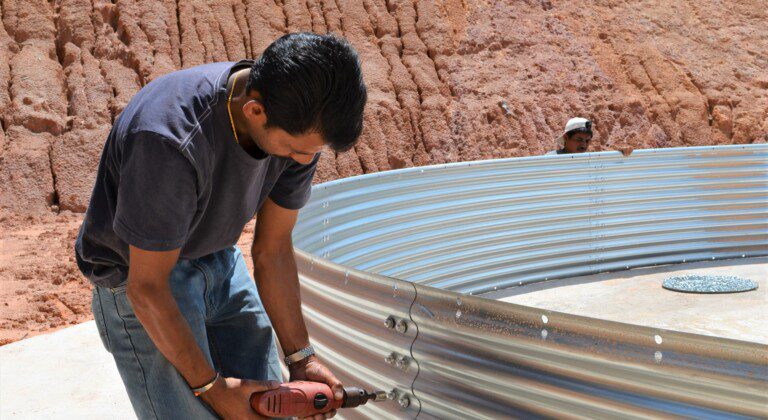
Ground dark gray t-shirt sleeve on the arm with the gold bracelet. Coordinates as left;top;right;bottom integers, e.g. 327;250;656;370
113;131;197;251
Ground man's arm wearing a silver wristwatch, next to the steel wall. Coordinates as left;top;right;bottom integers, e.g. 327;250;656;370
251;199;343;406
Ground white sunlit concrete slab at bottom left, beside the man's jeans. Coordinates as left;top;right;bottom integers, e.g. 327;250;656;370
0;321;136;420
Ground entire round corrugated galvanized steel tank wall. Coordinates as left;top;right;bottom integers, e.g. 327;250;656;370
294;145;768;418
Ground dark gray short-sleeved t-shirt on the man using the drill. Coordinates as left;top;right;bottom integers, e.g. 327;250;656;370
75;61;319;287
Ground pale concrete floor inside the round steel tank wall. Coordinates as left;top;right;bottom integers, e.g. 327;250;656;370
483;258;768;344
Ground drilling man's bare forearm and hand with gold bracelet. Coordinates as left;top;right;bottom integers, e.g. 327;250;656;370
126;246;279;418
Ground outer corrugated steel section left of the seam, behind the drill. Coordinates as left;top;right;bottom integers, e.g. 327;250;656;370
296;250;419;418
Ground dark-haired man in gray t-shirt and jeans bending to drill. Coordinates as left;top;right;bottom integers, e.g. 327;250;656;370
75;33;366;418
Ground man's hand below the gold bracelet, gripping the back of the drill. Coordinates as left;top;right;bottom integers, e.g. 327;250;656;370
200;377;280;420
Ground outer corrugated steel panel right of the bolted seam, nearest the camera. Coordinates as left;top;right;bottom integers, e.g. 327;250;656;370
411;286;768;419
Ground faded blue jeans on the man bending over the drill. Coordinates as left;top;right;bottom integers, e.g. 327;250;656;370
92;247;282;419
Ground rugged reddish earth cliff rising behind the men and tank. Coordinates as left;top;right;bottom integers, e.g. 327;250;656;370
0;0;768;213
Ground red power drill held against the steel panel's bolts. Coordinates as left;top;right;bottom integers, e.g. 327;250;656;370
251;381;388;417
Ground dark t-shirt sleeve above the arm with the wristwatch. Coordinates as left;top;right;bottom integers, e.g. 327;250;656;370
269;153;320;210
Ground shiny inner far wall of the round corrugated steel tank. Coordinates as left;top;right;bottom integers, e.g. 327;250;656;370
296;145;768;294
